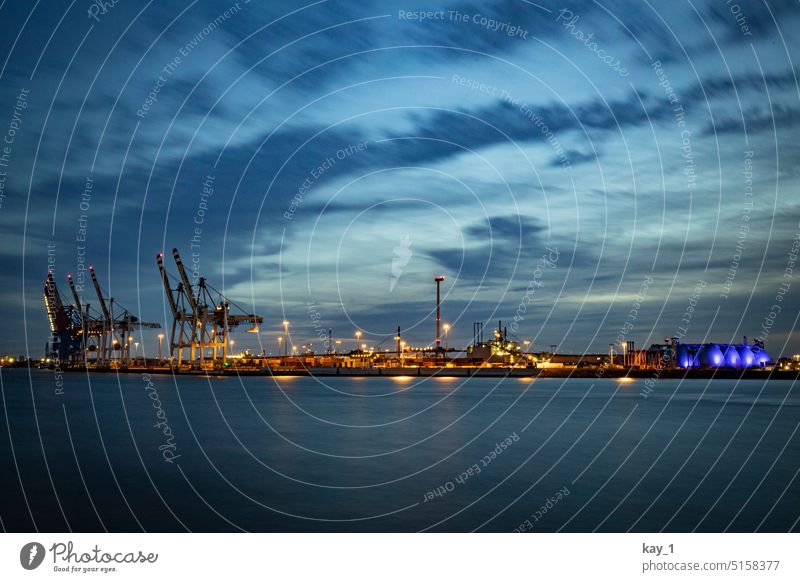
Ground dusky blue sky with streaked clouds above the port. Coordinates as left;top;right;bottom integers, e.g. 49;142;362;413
0;0;800;356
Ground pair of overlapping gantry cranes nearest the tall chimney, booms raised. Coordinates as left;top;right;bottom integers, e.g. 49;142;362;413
156;249;264;368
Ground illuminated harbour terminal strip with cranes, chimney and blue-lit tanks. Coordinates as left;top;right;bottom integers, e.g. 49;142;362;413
38;249;788;376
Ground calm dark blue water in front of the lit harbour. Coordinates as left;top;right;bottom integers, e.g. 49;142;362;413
0;369;800;532
